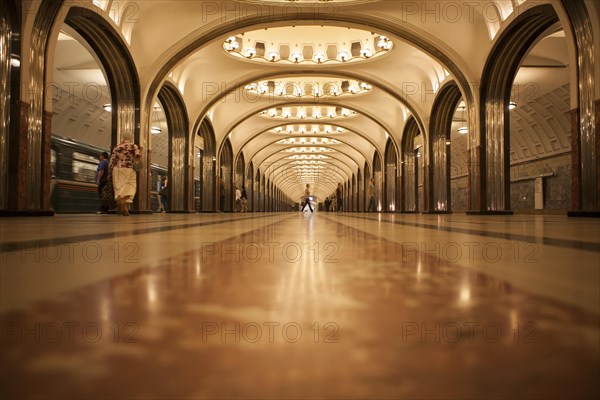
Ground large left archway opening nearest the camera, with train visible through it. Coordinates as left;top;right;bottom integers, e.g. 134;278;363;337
50;24;116;213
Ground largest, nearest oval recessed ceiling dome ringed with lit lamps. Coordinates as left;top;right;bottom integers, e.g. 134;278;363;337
223;25;394;65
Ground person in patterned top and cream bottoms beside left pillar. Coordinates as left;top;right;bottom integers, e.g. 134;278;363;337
109;133;141;216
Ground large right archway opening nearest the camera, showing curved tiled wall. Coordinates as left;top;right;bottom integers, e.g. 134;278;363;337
508;28;572;213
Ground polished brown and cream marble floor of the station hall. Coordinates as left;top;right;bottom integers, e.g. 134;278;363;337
0;213;600;399
